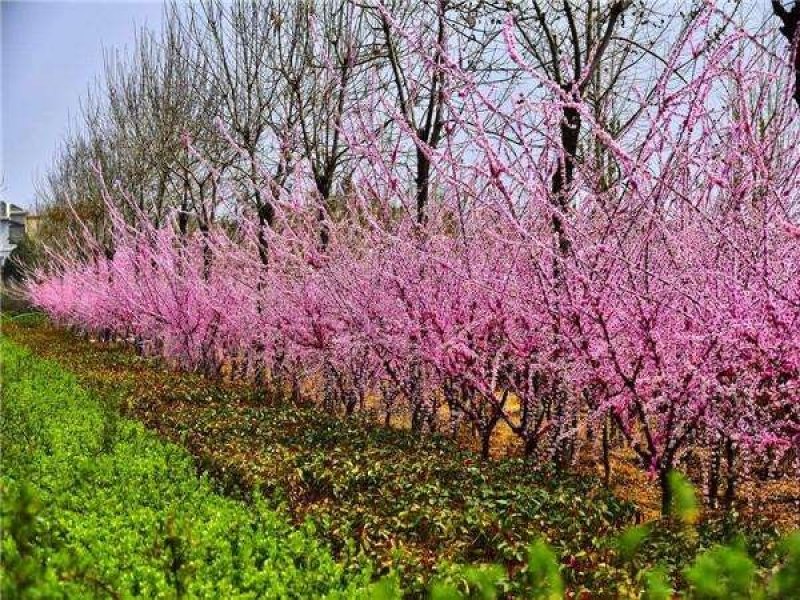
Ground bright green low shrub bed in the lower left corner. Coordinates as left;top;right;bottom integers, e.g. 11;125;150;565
0;339;370;598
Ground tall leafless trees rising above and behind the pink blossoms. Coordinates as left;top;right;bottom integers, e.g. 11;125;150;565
40;0;712;248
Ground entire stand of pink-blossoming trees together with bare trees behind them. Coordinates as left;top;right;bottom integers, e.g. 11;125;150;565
28;0;800;507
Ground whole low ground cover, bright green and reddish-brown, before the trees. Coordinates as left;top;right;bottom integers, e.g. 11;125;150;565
0;317;800;598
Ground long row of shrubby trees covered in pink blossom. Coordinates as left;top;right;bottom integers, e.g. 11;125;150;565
28;3;800;506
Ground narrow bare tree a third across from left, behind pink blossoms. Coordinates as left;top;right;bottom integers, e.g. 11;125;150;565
186;0;301;264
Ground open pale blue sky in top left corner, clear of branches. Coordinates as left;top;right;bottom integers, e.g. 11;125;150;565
0;0;162;208
